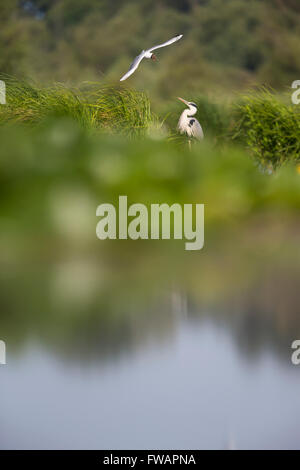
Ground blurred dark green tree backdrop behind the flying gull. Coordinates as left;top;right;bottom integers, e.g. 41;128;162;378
0;0;300;94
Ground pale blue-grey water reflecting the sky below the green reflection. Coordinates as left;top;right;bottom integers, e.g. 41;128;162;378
1;319;300;449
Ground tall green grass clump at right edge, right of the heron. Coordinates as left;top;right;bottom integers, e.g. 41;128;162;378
234;89;300;169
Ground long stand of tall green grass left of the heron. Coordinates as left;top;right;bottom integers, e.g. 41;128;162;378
0;76;155;137
